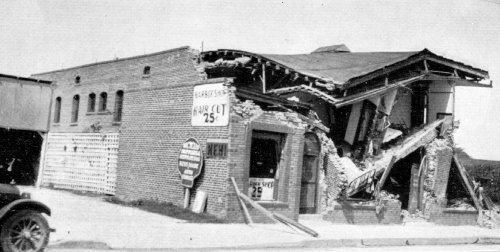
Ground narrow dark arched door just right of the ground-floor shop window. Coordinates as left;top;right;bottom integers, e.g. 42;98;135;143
299;133;320;214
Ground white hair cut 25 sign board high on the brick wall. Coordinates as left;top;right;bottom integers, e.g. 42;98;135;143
191;83;229;126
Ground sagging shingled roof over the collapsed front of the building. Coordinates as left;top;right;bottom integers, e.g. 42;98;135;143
203;48;489;89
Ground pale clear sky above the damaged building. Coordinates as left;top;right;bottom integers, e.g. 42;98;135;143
0;0;500;160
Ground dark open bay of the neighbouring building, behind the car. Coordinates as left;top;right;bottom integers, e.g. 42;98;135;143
0;128;43;185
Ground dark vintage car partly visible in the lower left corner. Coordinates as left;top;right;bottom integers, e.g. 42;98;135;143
0;184;52;252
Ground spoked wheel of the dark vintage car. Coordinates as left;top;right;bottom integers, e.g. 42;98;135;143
0;210;50;252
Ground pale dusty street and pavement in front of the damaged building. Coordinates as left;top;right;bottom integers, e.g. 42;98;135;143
10;187;500;251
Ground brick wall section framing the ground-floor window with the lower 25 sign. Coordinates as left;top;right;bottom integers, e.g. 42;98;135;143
227;100;305;222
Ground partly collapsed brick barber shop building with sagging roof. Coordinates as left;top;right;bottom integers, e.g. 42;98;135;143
26;45;492;224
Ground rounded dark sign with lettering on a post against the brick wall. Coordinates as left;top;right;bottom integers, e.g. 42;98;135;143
178;138;203;188
